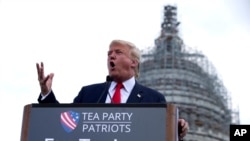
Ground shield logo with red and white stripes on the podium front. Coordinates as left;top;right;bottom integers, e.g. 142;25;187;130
61;111;80;133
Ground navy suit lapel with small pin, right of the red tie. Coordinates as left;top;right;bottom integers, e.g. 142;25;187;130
126;82;143;103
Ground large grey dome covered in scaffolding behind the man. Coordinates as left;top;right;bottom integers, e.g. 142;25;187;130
138;5;239;141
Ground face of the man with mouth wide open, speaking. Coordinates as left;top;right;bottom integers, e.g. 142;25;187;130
108;44;136;81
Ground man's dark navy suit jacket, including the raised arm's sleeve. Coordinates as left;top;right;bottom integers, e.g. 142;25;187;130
38;82;166;103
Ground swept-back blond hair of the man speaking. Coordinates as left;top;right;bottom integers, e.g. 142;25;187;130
109;40;141;78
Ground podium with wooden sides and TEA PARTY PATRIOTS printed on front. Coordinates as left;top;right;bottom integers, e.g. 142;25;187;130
21;104;178;141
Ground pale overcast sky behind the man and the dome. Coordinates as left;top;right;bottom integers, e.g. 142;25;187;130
0;0;250;140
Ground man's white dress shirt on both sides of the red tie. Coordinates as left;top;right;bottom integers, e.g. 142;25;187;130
105;77;135;103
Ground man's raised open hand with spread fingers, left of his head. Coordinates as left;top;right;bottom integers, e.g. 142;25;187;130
36;62;54;96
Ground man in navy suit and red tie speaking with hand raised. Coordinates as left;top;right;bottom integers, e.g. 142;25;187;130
36;40;188;138
